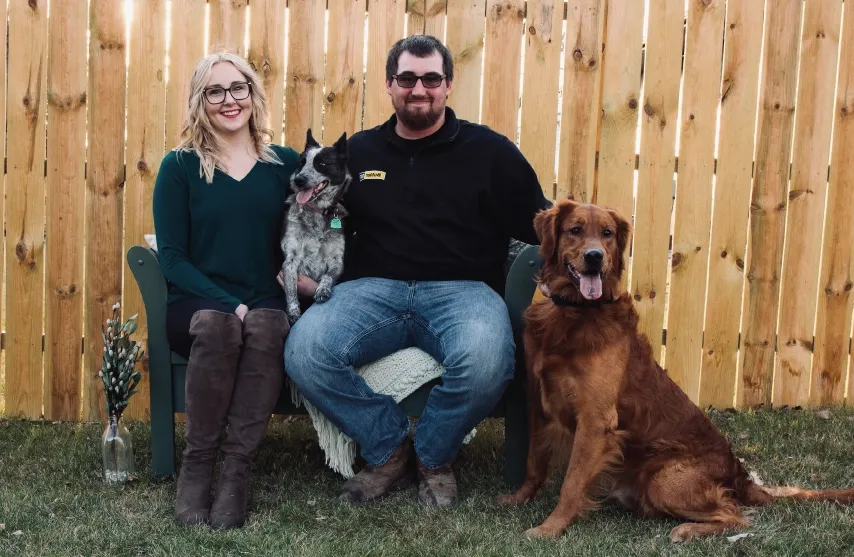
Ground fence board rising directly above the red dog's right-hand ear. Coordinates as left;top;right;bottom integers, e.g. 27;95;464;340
593;0;644;220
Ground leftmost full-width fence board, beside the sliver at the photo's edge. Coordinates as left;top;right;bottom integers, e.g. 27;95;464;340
6;0;47;418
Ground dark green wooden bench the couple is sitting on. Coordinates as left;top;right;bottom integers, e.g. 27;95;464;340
127;241;540;486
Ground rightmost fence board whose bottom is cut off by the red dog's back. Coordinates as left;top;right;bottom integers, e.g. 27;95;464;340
667;0;726;403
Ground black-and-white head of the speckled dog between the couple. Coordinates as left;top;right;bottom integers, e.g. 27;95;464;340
291;128;347;209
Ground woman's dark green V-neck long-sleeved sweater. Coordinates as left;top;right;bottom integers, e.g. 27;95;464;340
153;145;299;311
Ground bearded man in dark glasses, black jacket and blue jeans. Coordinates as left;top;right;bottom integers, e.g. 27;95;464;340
284;35;549;507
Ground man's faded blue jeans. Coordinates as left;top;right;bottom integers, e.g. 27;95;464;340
285;278;515;468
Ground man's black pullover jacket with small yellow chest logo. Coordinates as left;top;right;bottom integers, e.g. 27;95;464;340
344;108;550;294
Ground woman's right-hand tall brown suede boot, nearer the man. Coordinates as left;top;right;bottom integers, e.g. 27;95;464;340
211;308;290;529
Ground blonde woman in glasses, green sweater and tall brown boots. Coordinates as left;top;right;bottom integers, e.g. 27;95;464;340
153;53;299;528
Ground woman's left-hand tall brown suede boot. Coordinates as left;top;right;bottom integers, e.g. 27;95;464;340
175;310;243;525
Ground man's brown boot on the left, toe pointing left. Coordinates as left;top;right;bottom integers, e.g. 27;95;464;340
338;436;413;505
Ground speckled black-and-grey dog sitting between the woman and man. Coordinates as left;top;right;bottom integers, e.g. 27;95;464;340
282;129;351;323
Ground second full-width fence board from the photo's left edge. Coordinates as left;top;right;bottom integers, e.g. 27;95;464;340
44;0;88;420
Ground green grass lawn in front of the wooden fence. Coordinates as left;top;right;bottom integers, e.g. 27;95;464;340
0;410;854;557
